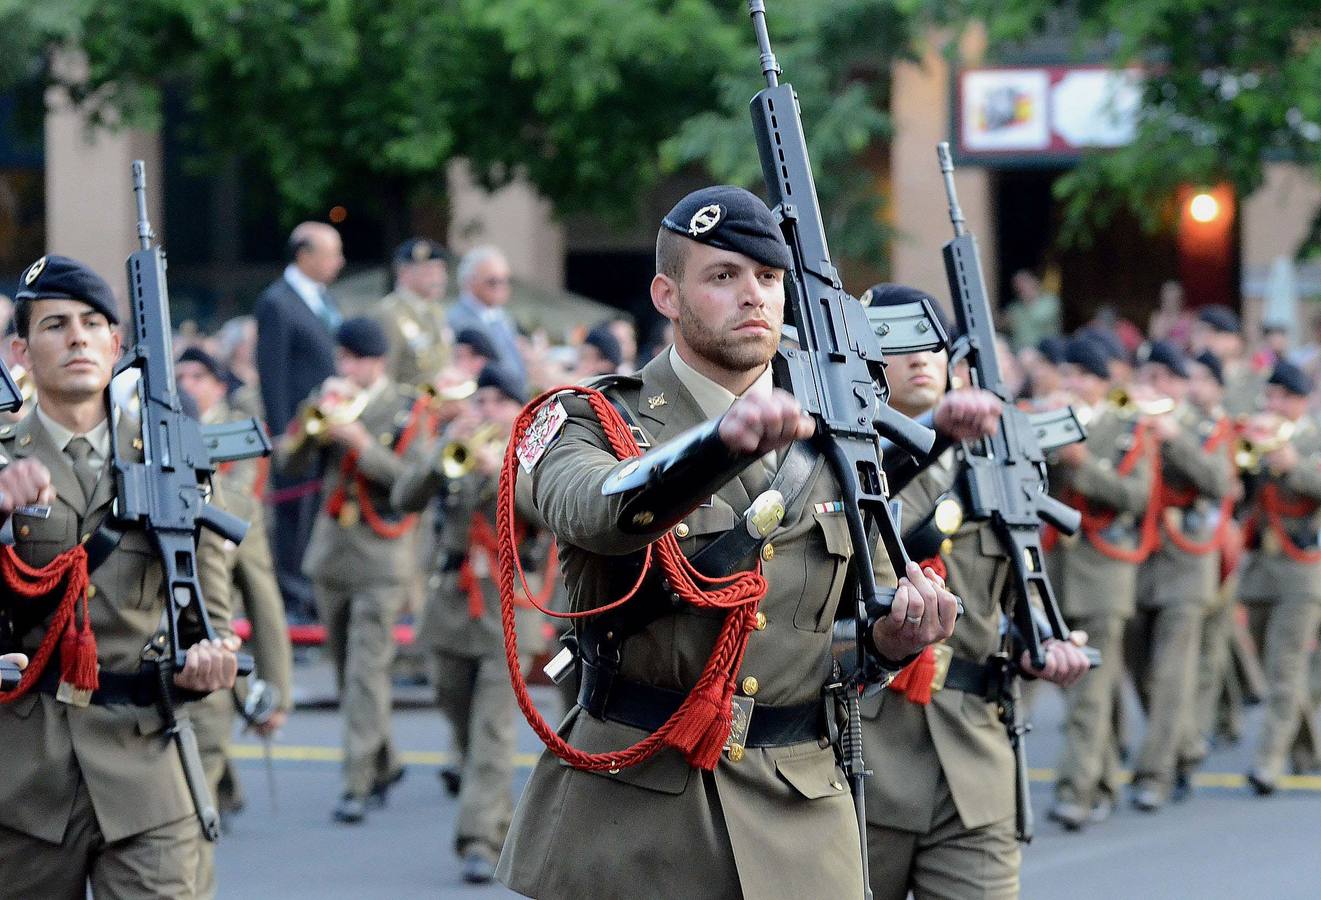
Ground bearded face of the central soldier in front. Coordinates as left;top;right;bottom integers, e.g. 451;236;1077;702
651;242;785;373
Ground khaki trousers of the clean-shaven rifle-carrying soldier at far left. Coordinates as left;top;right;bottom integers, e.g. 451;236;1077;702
0;781;202;900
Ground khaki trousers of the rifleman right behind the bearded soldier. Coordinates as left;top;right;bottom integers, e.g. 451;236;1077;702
867;774;1021;900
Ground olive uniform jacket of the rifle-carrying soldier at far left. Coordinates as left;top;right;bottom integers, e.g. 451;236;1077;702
0;412;230;845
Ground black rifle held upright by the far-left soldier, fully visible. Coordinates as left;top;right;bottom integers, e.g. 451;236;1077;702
110;160;271;841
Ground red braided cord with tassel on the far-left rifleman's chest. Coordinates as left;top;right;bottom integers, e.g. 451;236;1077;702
0;543;100;703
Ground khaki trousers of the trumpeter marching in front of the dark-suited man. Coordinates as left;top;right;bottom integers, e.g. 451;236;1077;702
314;580;408;797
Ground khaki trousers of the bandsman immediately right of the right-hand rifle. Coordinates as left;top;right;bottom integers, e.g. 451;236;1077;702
1055;616;1124;806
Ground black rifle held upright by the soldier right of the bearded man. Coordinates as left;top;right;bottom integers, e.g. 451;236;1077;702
937;143;1100;842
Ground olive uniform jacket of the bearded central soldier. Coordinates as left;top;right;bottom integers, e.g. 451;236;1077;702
497;354;890;900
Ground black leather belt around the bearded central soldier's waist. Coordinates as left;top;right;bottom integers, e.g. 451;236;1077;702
579;655;826;747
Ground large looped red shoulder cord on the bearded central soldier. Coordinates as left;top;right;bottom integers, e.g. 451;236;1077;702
495;385;766;772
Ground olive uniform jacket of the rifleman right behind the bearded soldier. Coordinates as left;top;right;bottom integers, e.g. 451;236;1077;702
863;453;1015;834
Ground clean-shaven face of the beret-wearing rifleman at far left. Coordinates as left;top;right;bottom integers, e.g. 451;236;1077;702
13;300;120;403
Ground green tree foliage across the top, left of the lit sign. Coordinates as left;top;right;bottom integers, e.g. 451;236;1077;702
0;0;918;265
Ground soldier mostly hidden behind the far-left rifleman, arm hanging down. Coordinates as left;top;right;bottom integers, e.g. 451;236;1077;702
174;348;293;840
